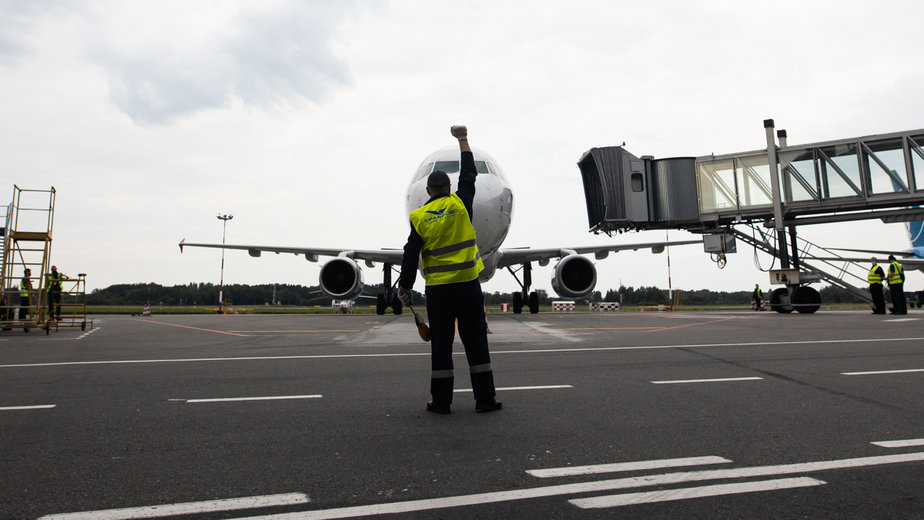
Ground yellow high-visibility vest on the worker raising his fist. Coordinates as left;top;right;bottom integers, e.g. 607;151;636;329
410;193;484;285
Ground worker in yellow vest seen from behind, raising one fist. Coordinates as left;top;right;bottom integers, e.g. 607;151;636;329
398;126;501;414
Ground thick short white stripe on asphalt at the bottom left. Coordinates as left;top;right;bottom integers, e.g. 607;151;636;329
39;493;309;520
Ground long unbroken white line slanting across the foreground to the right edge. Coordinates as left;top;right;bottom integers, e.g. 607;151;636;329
226;453;924;520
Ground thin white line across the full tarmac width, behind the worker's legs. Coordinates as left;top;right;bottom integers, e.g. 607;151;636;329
0;338;924;374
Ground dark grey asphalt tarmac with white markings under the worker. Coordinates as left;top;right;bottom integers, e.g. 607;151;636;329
0;309;924;520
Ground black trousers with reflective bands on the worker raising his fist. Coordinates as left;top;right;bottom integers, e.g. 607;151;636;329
426;279;495;405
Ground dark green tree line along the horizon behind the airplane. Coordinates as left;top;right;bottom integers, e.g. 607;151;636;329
87;283;863;307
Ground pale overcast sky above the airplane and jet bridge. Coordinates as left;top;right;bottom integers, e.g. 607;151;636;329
0;0;924;300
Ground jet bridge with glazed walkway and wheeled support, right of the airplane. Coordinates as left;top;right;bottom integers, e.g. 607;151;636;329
578;119;924;313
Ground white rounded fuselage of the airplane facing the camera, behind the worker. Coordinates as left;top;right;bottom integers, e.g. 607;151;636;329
405;146;513;282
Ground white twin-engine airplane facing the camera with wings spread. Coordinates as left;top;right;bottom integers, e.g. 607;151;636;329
179;146;702;315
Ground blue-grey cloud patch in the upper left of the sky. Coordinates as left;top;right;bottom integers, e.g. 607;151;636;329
92;2;351;125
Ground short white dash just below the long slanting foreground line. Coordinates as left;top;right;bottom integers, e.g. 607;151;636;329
568;477;826;509
